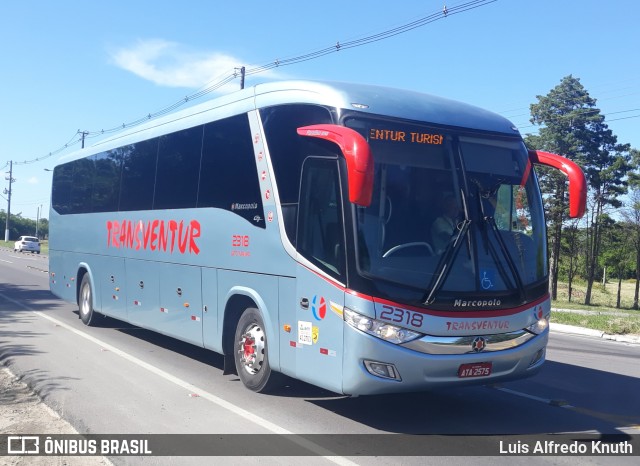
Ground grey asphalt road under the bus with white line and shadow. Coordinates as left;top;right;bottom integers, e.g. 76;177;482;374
0;249;640;464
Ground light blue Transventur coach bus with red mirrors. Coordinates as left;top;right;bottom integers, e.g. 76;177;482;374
49;81;586;396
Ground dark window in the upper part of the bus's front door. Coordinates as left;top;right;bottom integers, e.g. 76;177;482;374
297;157;345;277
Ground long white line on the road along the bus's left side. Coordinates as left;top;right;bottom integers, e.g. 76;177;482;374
0;293;357;466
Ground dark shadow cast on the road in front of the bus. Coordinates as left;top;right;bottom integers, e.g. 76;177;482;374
307;361;640;435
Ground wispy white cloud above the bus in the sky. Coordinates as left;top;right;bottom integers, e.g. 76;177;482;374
111;39;243;88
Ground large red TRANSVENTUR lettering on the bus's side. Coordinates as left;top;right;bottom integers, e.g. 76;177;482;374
107;220;201;254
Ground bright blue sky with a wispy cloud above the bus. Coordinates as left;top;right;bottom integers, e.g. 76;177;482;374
0;0;640;225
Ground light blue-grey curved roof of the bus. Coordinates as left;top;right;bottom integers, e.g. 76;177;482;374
59;81;519;163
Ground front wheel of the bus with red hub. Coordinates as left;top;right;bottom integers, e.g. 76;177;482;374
233;307;279;393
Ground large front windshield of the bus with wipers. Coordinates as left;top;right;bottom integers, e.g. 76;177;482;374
347;119;547;304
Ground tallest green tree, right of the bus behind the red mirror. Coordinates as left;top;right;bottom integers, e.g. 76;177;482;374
527;75;630;304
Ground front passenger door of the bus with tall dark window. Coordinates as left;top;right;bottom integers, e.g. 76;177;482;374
290;157;346;392
